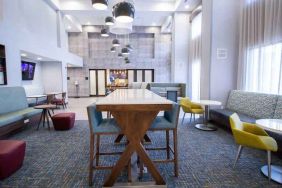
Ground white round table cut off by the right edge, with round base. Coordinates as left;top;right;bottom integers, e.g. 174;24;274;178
256;119;282;184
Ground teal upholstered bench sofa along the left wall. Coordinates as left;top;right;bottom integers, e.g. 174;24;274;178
0;87;42;136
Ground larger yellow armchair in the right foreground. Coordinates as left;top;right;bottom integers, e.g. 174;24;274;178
229;113;278;180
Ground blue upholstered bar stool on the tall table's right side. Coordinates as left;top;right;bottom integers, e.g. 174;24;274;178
146;103;180;177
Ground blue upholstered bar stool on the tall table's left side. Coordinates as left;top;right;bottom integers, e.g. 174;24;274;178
87;104;121;186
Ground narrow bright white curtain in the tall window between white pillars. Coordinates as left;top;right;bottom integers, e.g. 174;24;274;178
190;13;202;100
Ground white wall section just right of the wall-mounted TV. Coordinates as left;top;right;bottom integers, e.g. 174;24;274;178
41;62;63;93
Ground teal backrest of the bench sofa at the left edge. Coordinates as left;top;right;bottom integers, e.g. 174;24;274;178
0;87;28;114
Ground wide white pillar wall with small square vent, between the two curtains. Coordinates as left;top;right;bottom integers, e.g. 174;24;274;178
210;0;240;103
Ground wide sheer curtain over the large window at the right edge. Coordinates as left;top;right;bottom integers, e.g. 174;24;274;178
238;0;282;94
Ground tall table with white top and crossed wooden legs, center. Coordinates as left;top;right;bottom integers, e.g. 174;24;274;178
96;89;172;187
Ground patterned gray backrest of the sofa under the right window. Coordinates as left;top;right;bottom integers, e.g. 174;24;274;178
226;90;277;119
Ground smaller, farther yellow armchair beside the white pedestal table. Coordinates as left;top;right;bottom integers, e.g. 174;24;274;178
180;97;204;123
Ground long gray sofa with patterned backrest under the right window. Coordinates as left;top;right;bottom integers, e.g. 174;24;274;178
210;90;282;156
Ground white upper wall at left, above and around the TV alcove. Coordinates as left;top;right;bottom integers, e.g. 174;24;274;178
0;0;83;89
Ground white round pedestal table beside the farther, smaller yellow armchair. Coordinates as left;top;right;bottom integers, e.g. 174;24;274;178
192;100;221;131
